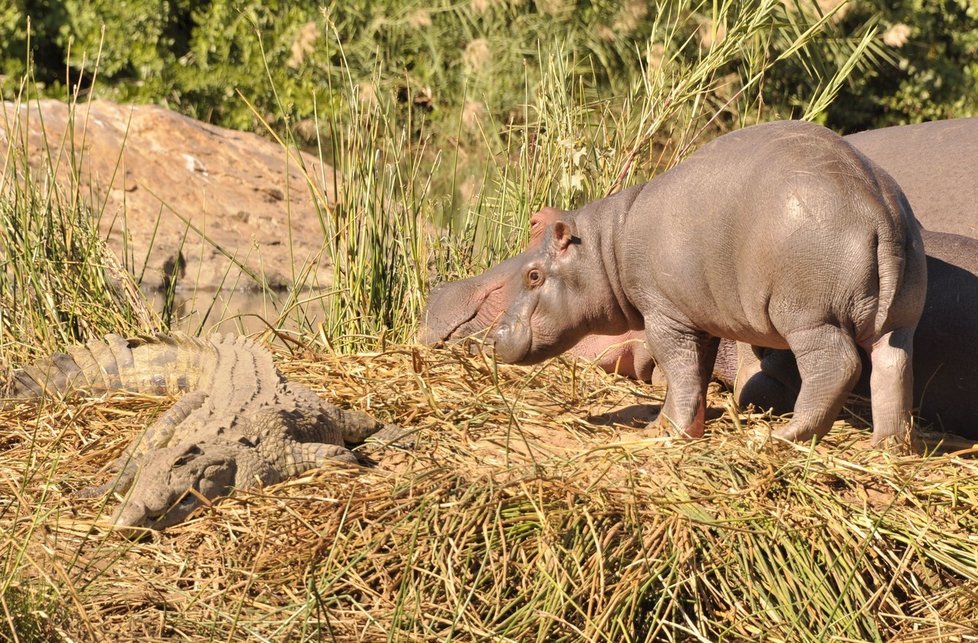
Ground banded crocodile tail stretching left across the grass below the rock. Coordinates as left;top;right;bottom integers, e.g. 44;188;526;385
5;333;242;397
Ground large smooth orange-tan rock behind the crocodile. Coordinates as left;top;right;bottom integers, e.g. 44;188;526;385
0;100;335;290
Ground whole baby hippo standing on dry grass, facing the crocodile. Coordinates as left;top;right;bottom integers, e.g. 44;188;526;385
486;122;927;444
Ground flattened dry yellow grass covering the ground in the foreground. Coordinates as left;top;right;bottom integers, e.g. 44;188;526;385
0;346;978;641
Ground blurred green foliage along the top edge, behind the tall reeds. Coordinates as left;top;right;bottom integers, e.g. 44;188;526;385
0;0;978;137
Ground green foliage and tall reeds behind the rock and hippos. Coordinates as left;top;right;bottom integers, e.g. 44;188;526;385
0;0;978;347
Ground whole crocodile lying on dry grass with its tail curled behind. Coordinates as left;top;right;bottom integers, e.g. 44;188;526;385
6;333;396;535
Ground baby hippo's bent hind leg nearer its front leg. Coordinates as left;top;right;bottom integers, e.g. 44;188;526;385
774;324;862;442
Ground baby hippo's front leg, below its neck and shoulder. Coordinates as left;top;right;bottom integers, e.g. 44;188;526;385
646;328;720;438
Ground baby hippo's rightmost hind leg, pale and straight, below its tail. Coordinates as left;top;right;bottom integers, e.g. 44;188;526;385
866;327;915;448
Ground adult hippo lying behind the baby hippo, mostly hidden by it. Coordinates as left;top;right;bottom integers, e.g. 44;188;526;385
421;118;978;437
